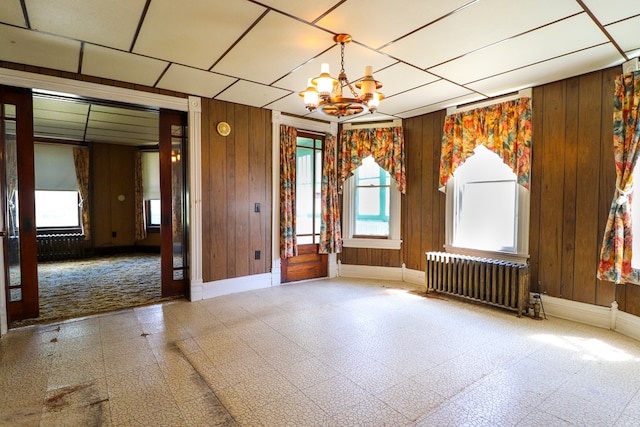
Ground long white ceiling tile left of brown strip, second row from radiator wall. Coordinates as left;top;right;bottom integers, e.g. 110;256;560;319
429;13;608;84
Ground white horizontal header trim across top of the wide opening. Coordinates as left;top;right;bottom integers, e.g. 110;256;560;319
0;68;189;111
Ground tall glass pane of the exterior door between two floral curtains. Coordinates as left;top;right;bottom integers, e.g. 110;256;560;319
296;132;322;245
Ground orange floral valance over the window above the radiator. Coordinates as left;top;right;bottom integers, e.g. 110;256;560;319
439;97;531;192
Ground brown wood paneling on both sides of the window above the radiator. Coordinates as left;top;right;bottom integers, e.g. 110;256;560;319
390;67;640;315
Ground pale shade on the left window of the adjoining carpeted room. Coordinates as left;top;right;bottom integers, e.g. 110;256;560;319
34;144;78;191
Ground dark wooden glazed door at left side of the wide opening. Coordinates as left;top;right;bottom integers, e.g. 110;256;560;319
0;86;39;323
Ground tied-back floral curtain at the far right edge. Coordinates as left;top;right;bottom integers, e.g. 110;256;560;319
598;71;640;283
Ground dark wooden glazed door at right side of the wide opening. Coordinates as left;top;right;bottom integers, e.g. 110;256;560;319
160;109;189;297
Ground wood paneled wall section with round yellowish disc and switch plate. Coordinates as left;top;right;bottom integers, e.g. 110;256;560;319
202;99;272;282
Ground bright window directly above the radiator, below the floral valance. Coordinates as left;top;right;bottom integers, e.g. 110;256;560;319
446;146;529;262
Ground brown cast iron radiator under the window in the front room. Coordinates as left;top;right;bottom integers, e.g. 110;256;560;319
425;252;530;316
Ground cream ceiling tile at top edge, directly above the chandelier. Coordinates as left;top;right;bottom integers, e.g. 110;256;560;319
318;0;469;48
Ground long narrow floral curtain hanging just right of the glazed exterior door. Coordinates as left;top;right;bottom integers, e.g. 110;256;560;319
319;134;342;254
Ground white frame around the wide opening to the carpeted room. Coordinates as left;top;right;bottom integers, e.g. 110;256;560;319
0;68;202;335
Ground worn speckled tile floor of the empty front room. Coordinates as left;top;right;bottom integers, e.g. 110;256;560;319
0;279;640;426
